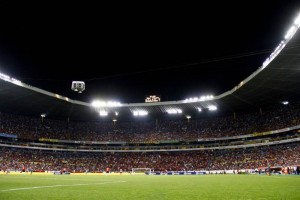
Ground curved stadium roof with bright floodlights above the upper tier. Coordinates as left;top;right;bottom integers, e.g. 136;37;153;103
0;14;300;121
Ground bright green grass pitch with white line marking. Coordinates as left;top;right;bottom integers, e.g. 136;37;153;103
0;174;300;200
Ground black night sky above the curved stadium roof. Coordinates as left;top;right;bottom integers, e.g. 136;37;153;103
0;1;300;103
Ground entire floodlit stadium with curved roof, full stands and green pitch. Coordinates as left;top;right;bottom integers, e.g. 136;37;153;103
0;3;300;200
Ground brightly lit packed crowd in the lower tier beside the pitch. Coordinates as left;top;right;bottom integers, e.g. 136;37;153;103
0;143;300;172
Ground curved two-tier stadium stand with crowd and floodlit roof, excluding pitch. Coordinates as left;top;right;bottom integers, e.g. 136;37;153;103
0;10;300;174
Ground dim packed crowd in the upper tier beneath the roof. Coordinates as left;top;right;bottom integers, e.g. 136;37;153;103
0;103;300;143
